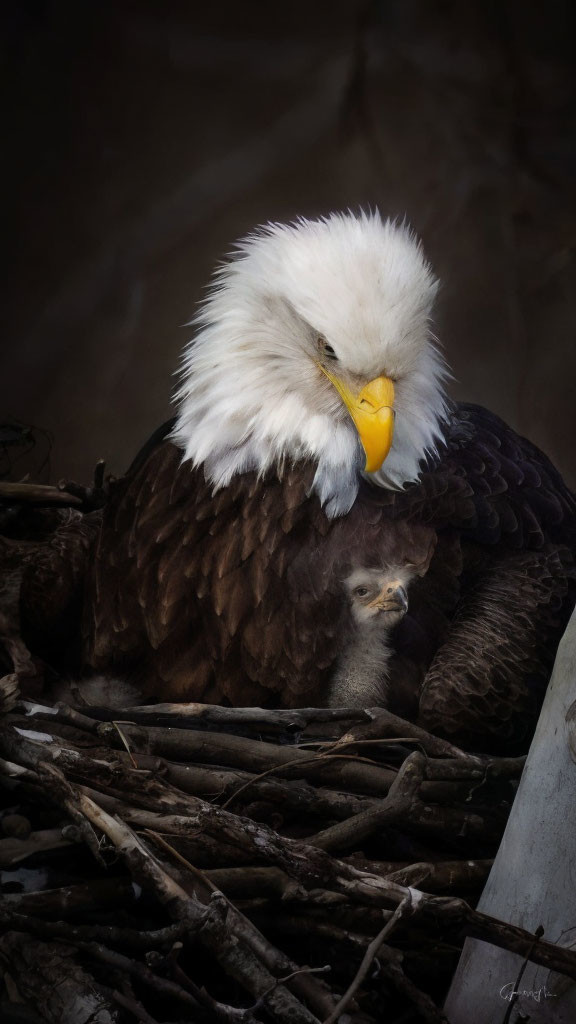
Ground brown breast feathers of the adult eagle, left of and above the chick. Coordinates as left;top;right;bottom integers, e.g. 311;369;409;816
86;444;431;705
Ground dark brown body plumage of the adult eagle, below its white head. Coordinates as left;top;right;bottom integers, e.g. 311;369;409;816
86;406;576;748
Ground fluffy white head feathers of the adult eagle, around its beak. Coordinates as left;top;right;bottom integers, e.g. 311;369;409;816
173;207;446;515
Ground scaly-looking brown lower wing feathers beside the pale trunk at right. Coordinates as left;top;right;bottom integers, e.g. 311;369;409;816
420;546;576;750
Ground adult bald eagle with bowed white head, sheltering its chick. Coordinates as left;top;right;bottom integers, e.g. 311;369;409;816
86;214;576;748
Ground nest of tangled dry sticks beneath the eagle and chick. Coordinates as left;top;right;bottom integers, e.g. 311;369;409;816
0;701;576;1024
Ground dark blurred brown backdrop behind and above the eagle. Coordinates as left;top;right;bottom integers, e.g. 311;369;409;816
0;0;576;485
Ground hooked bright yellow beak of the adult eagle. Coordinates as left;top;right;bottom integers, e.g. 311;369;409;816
319;364;394;473
